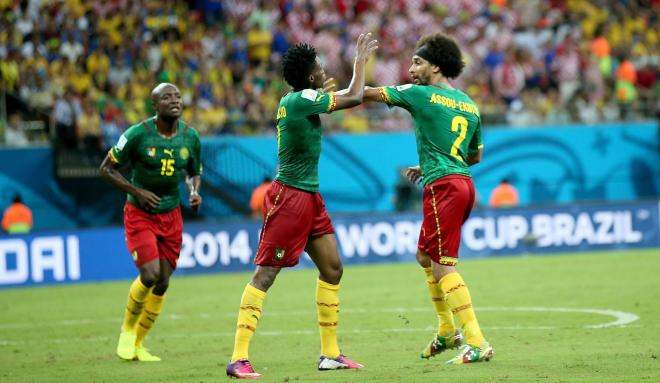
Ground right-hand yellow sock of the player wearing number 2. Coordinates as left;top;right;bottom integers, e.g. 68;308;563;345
440;273;484;347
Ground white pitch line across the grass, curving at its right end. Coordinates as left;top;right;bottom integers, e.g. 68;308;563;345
0;307;639;332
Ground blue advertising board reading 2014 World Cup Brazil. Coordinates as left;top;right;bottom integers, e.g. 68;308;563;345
0;201;660;287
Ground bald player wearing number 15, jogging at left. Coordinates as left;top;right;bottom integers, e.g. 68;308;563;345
100;83;202;362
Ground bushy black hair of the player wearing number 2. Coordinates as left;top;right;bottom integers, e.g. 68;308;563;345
415;32;465;78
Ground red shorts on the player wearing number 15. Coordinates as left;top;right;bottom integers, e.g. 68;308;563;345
124;202;183;268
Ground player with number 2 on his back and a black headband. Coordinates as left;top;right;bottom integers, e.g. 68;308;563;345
364;33;493;364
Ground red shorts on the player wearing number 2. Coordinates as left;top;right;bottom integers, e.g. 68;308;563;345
418;175;474;266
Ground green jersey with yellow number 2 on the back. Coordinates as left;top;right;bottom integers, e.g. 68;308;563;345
380;84;483;186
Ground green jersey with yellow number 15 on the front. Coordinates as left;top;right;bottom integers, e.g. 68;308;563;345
110;117;202;213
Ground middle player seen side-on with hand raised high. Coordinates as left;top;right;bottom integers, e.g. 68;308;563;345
227;34;377;378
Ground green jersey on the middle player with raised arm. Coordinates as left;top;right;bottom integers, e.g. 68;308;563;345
275;89;335;192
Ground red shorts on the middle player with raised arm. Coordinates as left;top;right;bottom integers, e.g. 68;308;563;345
254;181;335;267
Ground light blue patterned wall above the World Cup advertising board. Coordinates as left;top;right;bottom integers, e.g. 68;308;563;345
0;122;660;230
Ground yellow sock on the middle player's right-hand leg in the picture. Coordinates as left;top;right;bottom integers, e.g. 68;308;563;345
316;279;339;358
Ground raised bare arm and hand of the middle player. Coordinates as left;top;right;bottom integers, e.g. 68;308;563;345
334;33;378;110
